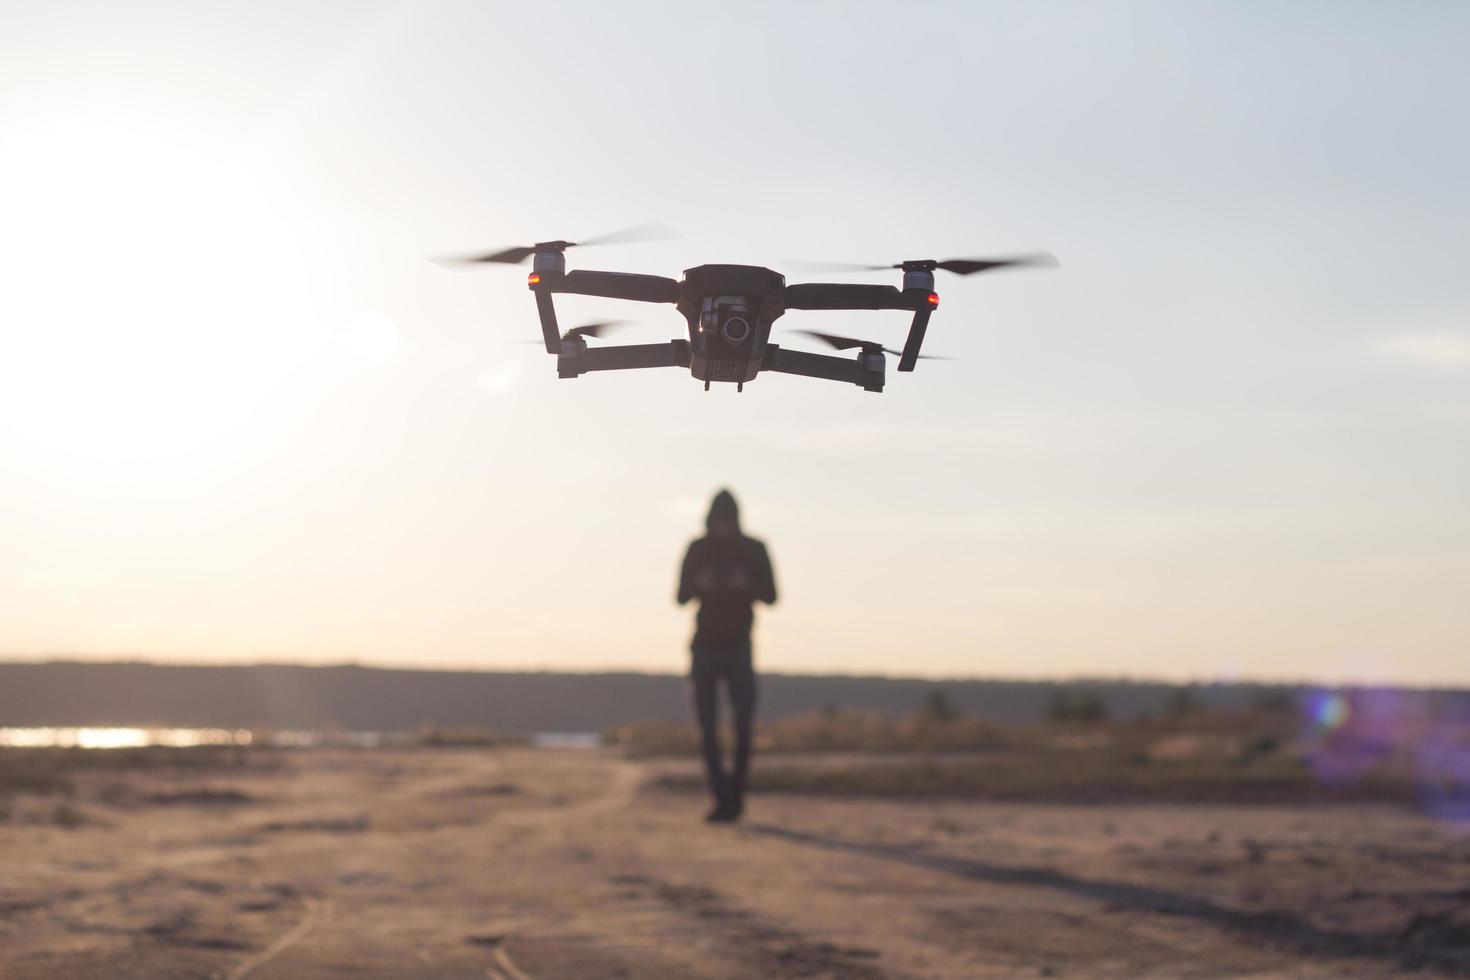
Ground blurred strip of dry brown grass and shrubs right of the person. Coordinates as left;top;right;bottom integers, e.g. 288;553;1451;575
607;699;1470;815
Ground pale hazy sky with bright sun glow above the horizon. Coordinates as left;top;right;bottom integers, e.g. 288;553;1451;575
0;0;1470;685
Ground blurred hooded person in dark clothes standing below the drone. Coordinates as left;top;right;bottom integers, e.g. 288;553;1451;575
678;489;776;823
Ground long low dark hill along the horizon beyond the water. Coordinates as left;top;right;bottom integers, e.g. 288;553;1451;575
0;661;1446;733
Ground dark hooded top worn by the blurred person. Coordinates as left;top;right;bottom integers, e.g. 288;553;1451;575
678;491;776;649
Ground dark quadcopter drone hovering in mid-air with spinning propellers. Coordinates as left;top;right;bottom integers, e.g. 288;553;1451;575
454;225;1057;392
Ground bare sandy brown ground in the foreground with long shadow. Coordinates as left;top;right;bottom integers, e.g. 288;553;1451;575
0;749;1470;980
